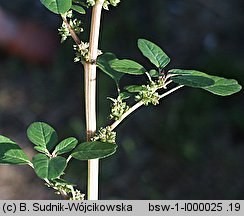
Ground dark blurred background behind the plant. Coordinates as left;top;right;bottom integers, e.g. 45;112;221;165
0;0;244;199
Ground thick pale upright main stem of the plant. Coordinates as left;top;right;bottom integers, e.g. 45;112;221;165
84;0;104;200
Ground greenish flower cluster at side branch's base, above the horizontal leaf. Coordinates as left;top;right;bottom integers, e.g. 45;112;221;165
92;126;116;143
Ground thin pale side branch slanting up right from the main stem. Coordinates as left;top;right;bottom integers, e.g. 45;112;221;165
110;85;184;131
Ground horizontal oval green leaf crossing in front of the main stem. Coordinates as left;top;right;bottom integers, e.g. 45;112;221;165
71;141;117;160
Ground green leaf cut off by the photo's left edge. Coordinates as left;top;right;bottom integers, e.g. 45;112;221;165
0;135;30;164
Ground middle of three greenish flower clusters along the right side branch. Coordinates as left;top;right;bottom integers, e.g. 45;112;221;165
108;96;130;120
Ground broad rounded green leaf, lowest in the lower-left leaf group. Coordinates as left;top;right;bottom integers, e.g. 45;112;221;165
32;154;67;179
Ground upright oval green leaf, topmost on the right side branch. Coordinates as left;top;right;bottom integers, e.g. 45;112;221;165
138;39;170;69
